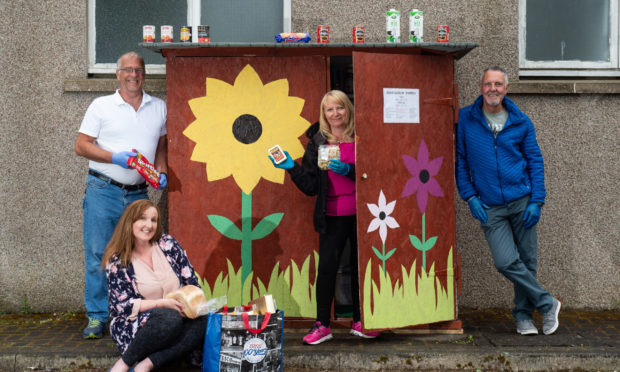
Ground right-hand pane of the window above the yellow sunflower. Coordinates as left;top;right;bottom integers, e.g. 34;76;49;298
200;0;283;42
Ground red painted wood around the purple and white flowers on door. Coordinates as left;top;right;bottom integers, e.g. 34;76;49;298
353;52;456;318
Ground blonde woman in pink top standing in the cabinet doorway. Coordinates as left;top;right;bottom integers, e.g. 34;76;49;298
272;90;378;345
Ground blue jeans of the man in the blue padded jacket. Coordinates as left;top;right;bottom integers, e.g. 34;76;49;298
481;196;553;321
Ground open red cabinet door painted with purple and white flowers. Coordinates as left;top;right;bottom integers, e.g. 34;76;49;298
353;52;456;329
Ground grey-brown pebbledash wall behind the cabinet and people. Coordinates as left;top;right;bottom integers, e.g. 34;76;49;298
0;0;620;313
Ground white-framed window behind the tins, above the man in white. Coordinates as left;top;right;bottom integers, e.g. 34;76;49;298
88;0;291;74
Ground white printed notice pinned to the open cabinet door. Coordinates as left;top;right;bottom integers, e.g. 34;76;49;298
383;88;420;124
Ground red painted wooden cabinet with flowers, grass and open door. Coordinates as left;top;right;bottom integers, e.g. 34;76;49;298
149;43;476;329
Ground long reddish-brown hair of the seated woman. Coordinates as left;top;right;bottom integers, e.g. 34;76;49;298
101;199;162;269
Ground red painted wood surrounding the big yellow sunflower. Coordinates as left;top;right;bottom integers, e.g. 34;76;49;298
166;54;327;285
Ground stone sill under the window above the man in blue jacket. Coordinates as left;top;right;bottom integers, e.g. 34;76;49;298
508;80;620;94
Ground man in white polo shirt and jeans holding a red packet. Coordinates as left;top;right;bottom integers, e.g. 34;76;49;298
75;52;167;338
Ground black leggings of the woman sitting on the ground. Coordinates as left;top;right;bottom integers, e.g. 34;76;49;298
121;308;207;367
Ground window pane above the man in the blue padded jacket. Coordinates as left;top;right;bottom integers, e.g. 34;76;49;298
525;0;610;62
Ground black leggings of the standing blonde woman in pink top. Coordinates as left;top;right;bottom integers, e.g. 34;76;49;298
316;215;361;327
